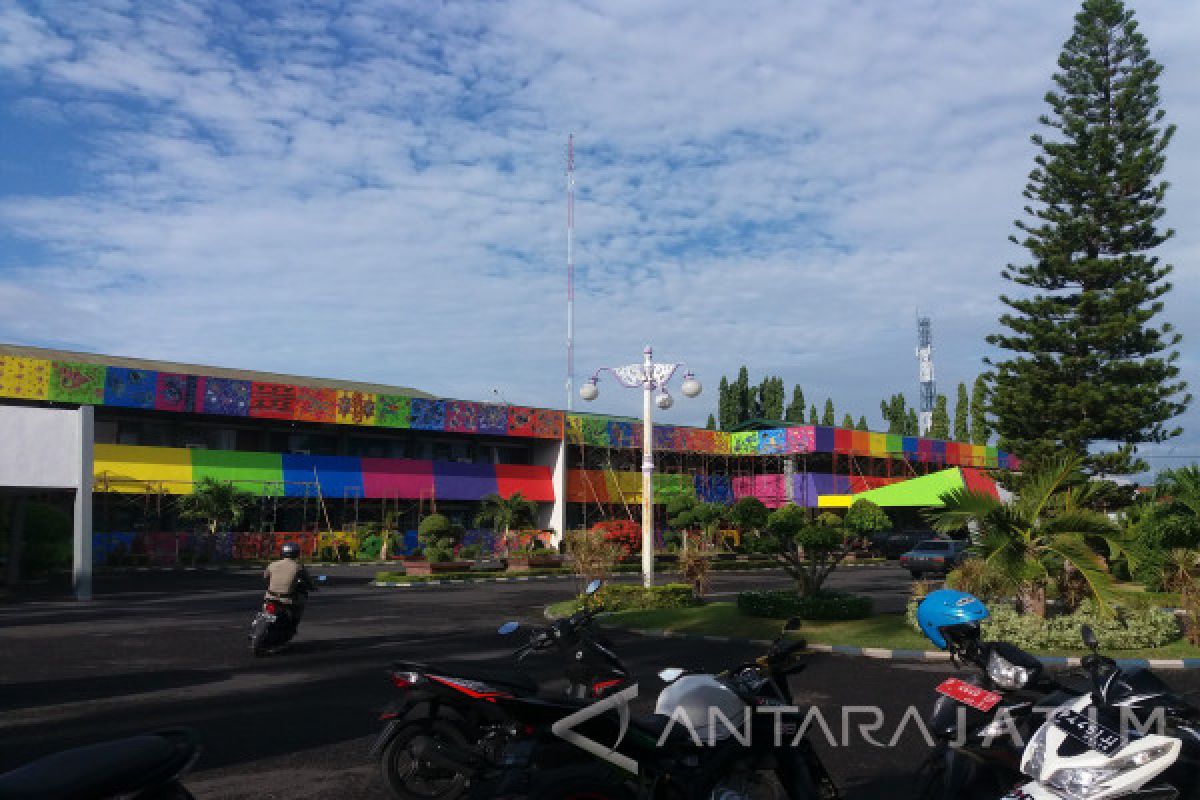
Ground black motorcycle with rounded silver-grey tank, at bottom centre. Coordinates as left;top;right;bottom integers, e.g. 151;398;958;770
479;619;839;800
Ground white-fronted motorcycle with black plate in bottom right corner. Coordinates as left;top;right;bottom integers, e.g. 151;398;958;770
1004;625;1200;800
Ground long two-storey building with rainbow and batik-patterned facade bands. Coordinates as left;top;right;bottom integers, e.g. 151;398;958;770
0;345;1015;575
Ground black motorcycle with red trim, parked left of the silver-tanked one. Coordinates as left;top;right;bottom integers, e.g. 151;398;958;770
370;581;629;800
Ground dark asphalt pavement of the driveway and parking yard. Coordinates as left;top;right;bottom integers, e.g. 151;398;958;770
0;567;1200;800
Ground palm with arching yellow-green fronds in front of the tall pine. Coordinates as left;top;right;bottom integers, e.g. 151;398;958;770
929;456;1128;616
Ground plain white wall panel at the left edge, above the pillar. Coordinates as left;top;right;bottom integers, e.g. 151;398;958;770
0;405;92;489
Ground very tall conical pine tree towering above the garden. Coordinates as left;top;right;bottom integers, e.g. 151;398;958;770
988;0;1192;474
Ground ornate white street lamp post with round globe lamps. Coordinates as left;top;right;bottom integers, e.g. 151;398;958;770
580;344;701;588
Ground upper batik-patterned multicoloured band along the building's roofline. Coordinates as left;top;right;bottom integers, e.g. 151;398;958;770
0;355;1019;469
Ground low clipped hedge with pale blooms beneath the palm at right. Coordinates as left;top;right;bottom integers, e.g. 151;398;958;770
907;600;1181;650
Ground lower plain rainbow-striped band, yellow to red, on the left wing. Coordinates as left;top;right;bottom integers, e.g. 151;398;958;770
94;445;554;503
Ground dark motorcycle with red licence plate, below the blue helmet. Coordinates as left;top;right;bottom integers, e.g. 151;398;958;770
913;628;1080;800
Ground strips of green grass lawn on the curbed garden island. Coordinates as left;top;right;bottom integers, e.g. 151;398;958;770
595;601;1200;658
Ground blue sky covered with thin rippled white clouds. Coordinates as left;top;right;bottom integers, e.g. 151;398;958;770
0;0;1200;472
